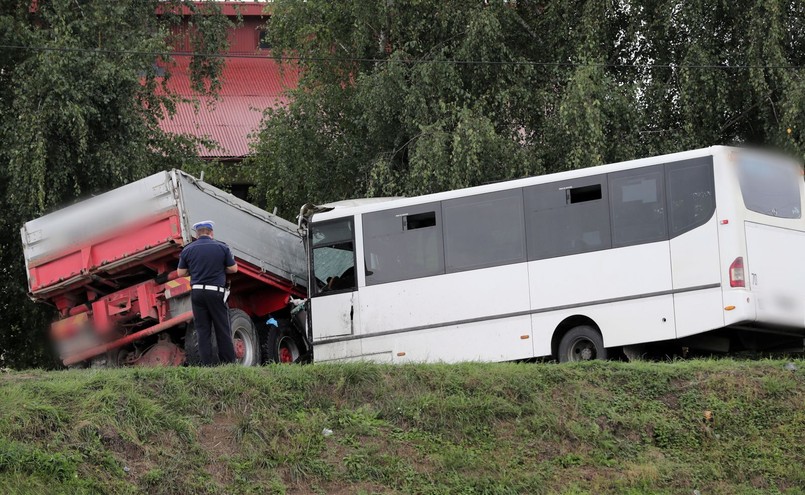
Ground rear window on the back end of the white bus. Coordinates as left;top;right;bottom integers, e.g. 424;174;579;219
738;155;802;218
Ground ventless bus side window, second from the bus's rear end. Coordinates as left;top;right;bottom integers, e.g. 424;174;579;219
609;165;668;247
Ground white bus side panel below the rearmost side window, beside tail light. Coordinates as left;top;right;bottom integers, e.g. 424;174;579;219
671;215;724;338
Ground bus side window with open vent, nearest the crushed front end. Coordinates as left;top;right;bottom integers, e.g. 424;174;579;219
363;203;444;285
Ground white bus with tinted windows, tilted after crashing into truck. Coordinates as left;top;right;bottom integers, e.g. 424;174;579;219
300;146;805;363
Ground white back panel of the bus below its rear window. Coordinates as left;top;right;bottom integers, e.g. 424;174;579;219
745;222;805;327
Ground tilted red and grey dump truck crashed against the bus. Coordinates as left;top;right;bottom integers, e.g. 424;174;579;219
21;170;311;367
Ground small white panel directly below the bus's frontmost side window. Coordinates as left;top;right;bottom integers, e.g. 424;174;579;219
310;292;360;340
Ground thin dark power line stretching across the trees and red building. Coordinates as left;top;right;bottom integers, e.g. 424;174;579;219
0;45;805;70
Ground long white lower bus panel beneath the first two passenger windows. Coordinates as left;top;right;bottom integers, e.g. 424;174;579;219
359;263;533;361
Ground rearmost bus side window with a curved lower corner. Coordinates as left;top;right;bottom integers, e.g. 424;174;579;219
665;156;716;238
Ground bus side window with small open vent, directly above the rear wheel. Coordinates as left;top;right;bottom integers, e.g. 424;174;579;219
523;176;612;261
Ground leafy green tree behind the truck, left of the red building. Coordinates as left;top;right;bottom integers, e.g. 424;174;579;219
0;0;231;367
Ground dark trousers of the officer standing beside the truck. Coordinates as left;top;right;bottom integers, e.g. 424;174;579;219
190;289;236;365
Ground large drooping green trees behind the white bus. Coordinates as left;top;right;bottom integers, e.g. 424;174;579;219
250;0;805;216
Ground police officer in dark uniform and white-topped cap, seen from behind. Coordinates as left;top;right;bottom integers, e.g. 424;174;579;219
177;220;238;365
